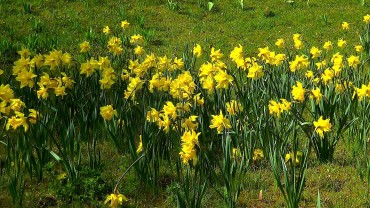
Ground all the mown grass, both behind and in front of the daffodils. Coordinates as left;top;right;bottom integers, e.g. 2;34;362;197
0;0;370;207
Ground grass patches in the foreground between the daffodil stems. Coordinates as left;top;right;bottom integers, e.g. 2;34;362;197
0;142;367;207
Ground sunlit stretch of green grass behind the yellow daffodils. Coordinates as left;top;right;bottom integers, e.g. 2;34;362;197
0;0;370;59
